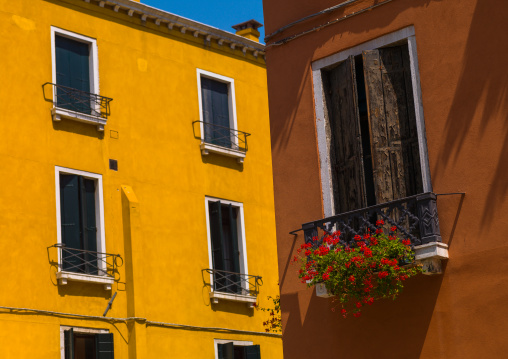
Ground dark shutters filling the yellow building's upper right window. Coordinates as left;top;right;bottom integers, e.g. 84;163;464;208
201;77;231;148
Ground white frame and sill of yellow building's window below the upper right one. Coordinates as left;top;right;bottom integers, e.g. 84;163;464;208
205;196;256;304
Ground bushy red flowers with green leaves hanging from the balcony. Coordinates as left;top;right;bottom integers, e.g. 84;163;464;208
293;220;422;317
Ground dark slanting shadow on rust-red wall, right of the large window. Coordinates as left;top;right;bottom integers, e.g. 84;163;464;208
433;0;508;225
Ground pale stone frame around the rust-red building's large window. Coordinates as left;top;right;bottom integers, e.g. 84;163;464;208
312;26;432;217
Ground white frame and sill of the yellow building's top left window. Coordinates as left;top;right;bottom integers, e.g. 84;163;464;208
51;26;106;130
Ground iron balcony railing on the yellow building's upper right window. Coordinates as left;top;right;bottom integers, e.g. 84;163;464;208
192;121;250;152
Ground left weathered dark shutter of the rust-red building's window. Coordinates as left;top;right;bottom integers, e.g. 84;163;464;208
324;56;367;212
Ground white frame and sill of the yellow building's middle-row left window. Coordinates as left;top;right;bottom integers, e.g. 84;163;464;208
55;166;110;290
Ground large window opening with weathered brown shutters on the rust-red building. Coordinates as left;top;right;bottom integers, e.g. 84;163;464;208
323;44;423;213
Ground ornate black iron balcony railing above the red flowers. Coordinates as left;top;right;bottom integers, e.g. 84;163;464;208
302;192;441;247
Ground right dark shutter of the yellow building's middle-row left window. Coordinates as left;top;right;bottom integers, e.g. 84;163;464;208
79;176;98;274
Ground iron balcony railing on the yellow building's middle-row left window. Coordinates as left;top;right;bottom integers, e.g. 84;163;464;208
48;243;123;278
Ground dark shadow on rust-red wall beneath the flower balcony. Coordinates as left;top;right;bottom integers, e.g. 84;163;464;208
281;275;444;359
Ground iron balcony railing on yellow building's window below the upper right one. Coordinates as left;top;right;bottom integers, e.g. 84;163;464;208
202;269;263;296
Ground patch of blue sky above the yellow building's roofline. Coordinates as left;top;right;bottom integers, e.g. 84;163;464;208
141;0;265;42
